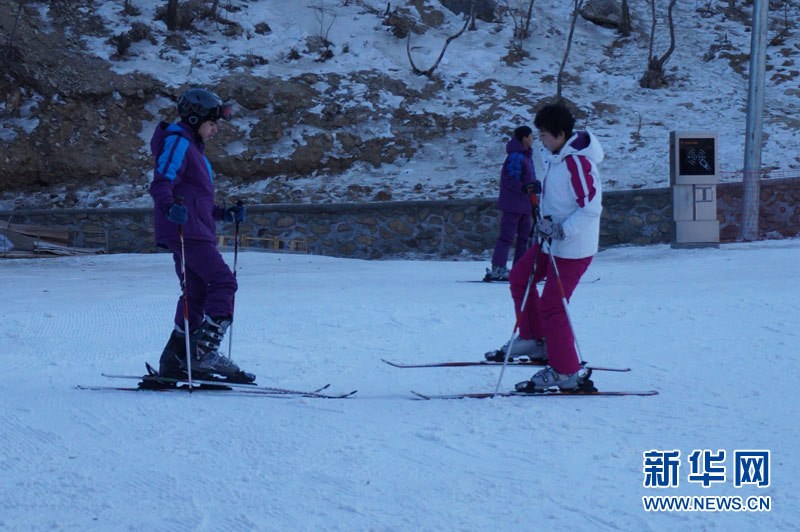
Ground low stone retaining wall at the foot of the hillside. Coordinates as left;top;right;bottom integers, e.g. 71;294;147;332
0;178;800;259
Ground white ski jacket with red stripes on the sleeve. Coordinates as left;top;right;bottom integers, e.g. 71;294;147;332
540;131;604;259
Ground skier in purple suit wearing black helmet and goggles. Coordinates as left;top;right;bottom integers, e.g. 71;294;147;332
150;88;255;382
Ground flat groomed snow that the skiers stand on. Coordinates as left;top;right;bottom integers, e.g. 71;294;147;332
0;239;800;531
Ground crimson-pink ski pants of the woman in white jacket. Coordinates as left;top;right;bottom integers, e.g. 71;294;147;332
508;244;592;373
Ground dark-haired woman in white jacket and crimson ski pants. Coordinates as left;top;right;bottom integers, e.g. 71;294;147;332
509;105;603;392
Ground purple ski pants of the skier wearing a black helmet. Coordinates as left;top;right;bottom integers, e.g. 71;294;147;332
167;240;237;331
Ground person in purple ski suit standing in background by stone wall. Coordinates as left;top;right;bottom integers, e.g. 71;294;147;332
484;126;538;281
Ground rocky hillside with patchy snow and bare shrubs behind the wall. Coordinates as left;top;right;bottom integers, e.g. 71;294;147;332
0;0;800;208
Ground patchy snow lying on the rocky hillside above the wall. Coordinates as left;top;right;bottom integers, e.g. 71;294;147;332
0;0;800;209
